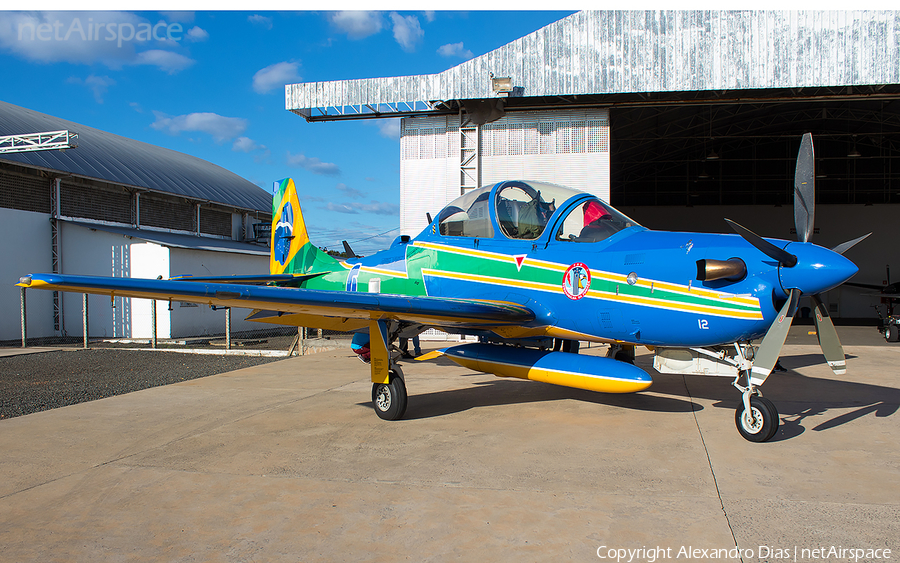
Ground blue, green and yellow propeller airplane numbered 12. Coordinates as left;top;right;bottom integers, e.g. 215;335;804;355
17;133;868;442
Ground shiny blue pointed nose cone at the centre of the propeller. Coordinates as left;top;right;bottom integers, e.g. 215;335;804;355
778;242;859;295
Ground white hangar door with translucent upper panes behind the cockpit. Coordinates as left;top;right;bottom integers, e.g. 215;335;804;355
400;109;609;236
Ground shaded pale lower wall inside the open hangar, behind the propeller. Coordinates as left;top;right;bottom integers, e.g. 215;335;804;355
619;205;900;318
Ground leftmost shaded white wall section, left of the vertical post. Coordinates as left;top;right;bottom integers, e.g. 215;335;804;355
0;208;53;340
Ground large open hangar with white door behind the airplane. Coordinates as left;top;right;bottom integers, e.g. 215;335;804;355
285;11;900;319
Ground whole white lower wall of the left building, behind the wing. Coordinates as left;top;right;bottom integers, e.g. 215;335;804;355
0;219;269;341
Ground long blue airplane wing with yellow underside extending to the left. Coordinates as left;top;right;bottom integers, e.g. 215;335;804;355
16;274;535;327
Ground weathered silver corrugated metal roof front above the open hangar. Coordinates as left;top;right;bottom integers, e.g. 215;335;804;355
285;10;900;117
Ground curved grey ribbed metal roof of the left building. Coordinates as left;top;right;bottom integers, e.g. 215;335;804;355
0;102;272;212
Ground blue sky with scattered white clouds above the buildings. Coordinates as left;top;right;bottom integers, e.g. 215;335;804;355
0;11;571;253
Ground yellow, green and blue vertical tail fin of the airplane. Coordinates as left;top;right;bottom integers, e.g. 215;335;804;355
269;178;338;274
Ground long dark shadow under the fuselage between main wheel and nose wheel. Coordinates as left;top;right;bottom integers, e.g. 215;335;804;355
358;372;703;419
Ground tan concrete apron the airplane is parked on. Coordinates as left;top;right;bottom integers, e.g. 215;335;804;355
0;346;900;561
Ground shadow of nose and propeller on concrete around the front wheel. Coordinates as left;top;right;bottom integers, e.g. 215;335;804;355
651;354;900;441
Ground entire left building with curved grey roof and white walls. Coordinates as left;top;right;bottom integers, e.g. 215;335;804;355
0;102;272;340
